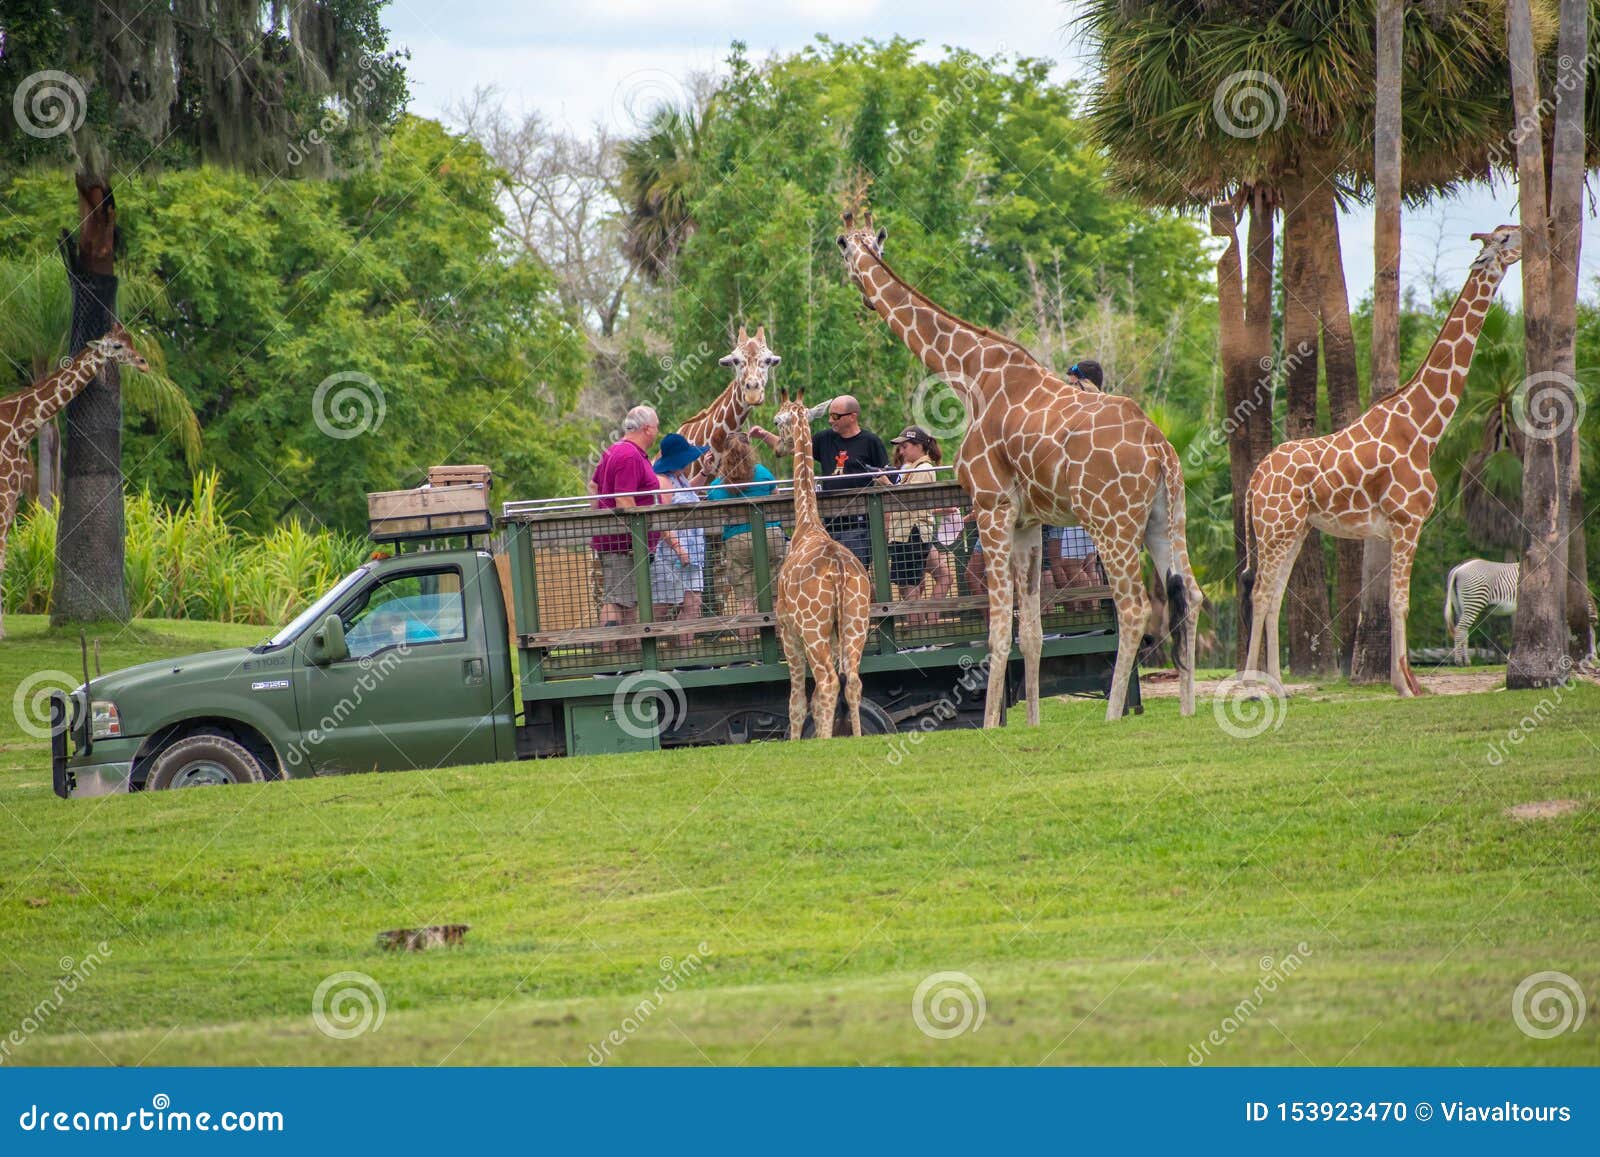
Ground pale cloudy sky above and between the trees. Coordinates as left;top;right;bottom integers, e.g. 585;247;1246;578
384;0;1600;306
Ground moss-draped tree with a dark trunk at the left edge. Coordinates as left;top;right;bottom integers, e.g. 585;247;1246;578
0;0;406;623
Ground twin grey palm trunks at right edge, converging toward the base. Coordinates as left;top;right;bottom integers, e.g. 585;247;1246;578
1506;0;1587;688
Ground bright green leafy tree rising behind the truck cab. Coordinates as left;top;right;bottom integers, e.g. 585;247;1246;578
0;117;587;531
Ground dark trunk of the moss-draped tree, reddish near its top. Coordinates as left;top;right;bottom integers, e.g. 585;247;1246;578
50;173;128;624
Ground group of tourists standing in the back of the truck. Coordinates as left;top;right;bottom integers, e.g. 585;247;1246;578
589;362;1102;640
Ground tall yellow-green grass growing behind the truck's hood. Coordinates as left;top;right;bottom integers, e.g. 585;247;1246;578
5;474;371;624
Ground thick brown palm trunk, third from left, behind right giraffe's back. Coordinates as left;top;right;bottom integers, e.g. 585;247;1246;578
1283;174;1338;675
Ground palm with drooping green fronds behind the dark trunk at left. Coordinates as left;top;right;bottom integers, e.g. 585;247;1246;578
0;258;200;504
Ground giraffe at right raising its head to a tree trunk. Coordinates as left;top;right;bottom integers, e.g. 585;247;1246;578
1240;226;1522;698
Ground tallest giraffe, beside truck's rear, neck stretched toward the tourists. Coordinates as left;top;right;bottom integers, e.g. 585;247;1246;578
838;213;1202;727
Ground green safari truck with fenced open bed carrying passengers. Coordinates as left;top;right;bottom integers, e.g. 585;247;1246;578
51;467;1139;799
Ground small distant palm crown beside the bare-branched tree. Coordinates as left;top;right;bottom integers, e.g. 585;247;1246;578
621;106;702;282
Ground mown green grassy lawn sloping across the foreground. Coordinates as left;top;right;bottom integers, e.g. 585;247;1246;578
0;616;1600;1066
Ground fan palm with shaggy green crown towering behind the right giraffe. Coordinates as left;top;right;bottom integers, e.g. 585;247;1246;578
1080;0;1536;671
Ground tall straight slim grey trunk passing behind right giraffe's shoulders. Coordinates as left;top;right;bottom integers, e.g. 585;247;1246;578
1350;0;1405;683
